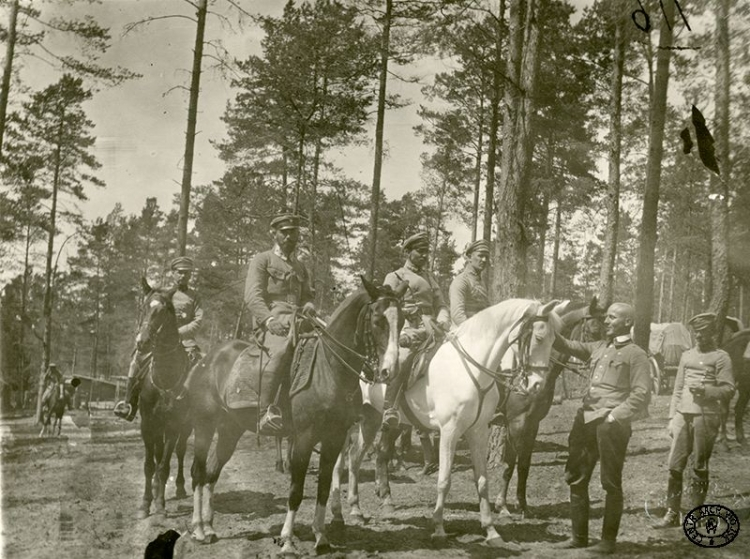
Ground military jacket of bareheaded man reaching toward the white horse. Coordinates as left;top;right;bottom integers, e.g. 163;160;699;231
555;337;651;423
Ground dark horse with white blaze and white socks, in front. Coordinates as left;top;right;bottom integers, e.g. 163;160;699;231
190;279;406;554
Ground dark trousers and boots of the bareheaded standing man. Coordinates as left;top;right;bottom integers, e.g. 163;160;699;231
565;409;631;541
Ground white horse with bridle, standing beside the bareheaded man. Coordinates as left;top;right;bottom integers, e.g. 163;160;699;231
331;299;562;545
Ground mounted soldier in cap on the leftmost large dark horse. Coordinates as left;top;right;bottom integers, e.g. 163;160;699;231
114;256;203;421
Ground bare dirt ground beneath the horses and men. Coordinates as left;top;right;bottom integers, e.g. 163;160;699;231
0;396;750;559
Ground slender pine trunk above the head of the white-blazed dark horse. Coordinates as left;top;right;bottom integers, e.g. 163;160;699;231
369;0;393;280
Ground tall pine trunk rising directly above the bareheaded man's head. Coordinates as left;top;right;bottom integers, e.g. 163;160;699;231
599;0;627;305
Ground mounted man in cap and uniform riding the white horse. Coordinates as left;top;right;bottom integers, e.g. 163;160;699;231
383;233;450;427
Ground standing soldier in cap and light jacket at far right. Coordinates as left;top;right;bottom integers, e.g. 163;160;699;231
653;313;734;528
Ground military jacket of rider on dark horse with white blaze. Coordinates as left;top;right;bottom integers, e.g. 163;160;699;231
245;247;313;326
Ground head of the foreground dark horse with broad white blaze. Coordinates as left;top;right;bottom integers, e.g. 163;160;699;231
360;276;409;382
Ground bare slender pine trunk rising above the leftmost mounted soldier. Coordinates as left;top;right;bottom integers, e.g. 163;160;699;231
177;0;208;255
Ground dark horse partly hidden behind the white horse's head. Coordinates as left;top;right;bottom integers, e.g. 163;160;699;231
495;297;606;518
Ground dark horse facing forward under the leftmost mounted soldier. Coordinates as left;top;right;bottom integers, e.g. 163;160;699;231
136;279;191;518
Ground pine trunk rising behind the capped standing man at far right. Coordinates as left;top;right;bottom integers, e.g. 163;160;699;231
709;0;730;342
